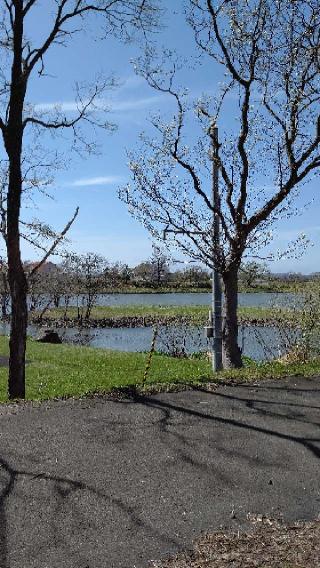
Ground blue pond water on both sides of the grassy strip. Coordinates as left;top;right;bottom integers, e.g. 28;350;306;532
0;293;297;361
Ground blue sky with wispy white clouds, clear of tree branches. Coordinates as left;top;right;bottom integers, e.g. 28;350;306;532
1;0;320;273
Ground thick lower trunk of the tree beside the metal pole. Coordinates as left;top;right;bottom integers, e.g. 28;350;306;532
222;267;242;369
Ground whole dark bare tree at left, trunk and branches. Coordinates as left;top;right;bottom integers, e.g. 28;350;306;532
0;0;157;398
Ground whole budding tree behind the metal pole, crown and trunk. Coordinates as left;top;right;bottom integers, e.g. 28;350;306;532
120;0;320;367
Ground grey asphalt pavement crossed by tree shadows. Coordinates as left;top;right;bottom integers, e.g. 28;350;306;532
0;379;320;568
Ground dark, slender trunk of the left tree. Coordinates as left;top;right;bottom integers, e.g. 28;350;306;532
4;0;28;399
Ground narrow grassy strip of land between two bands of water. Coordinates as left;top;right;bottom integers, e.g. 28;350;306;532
34;306;292;324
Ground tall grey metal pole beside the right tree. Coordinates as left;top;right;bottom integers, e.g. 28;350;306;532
210;122;222;372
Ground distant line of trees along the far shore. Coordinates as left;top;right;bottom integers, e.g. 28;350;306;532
0;249;320;317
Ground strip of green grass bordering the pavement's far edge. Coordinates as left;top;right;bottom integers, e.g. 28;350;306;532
0;336;320;402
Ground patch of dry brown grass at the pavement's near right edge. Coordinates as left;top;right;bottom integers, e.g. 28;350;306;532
151;517;320;568
